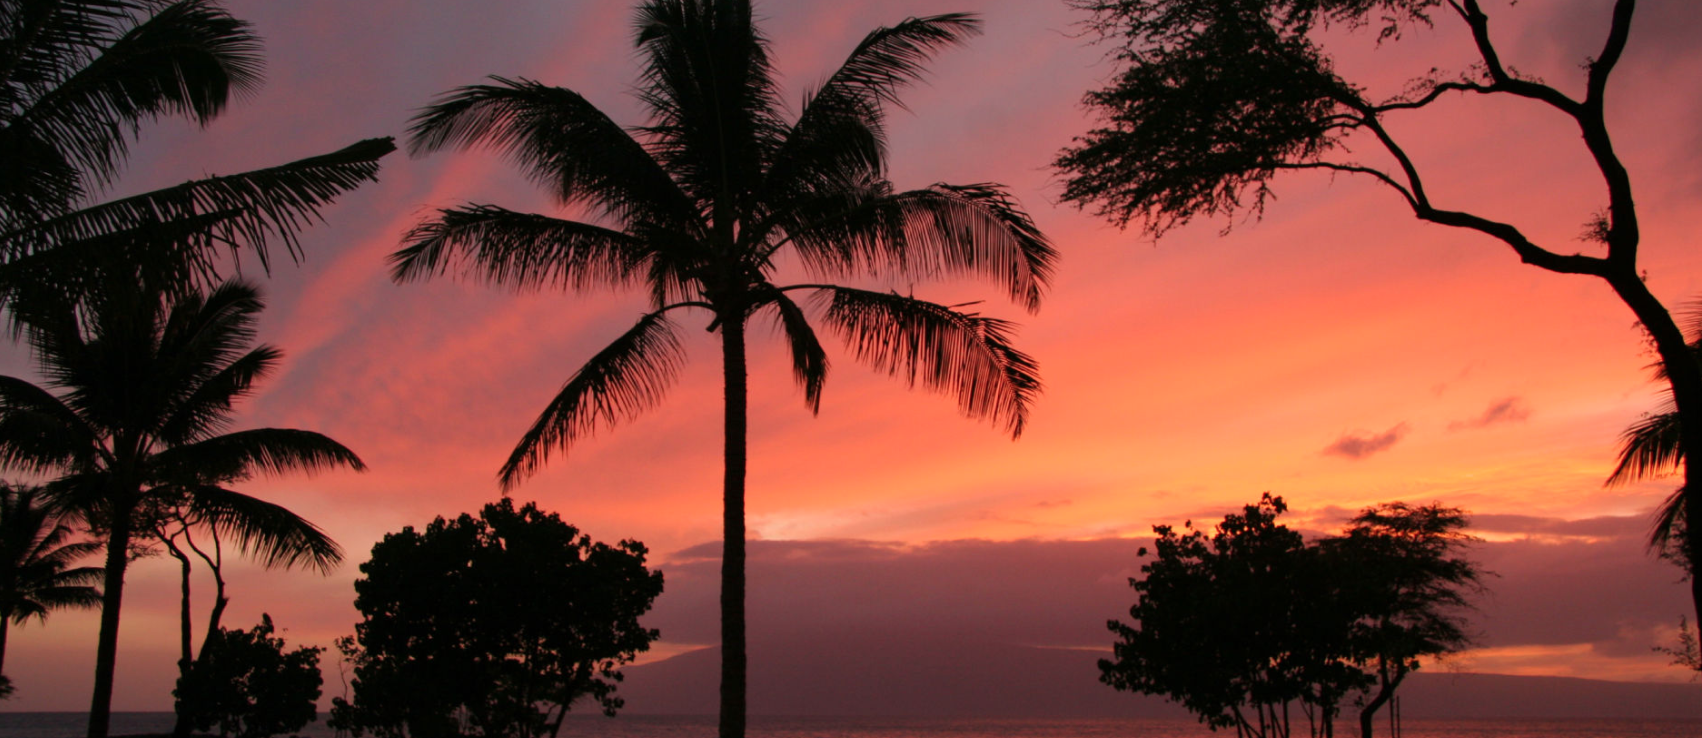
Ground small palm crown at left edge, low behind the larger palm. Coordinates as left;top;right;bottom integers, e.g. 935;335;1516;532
0;483;100;680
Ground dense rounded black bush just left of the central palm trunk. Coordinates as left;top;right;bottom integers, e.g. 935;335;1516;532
330;498;662;738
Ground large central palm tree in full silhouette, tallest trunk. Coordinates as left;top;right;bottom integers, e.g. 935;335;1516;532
391;0;1055;738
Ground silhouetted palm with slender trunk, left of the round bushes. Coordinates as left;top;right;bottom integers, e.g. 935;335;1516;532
0;267;364;738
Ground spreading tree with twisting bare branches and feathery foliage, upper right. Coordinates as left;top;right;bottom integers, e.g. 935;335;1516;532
1055;0;1702;632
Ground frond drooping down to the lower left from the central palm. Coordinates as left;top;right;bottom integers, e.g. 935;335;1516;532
499;311;684;490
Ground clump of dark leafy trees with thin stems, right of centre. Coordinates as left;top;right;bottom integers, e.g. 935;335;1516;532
1099;493;1484;738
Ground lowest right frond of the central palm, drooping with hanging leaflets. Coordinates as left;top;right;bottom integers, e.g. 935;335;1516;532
817;287;1040;439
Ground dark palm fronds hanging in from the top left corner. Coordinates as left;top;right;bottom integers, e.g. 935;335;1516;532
0;0;395;298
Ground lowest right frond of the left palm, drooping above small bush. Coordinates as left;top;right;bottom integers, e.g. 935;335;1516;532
191;485;342;573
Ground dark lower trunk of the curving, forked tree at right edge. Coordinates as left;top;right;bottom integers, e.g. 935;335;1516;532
1608;274;1702;622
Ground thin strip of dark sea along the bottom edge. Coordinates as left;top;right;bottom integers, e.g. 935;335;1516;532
0;712;1702;738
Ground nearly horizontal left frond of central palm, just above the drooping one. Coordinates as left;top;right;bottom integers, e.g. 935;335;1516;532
390;206;648;289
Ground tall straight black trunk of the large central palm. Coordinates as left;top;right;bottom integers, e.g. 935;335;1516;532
720;315;747;738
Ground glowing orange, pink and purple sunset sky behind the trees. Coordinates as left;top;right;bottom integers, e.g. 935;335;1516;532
13;0;1702;711
